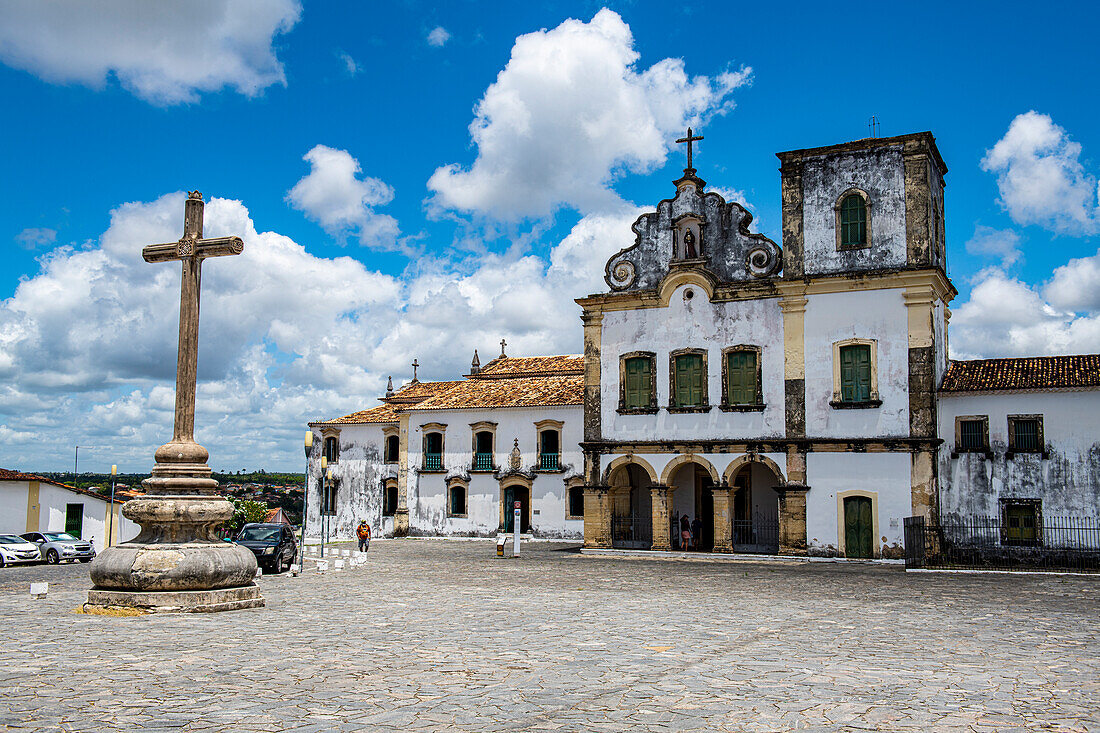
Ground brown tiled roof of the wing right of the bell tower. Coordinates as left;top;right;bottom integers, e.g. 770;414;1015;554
939;353;1100;392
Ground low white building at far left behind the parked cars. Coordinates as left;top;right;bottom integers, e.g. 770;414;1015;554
0;469;140;550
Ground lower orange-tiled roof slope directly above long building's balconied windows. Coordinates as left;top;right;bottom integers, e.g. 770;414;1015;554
408;375;584;411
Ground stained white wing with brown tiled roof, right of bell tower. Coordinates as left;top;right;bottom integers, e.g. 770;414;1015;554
938;354;1100;526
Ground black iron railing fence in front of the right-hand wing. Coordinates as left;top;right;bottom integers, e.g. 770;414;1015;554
903;516;1100;572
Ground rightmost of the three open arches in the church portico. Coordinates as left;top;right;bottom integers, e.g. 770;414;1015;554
729;460;782;555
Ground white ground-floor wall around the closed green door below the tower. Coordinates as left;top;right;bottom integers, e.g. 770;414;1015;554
806;452;913;555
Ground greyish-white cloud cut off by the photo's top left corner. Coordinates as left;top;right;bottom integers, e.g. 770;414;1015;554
0;0;301;105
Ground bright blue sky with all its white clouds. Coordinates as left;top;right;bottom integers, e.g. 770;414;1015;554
0;0;1100;470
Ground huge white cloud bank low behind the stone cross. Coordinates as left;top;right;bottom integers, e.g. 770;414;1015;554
0;193;637;470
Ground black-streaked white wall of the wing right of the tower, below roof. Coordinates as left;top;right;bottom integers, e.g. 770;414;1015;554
939;390;1100;519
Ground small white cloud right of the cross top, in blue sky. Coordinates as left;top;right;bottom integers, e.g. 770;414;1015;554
286;145;398;248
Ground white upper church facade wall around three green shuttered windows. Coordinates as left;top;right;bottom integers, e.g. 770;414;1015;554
600;285;784;440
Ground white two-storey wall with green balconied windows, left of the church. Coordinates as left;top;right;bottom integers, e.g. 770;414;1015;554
408;405;584;538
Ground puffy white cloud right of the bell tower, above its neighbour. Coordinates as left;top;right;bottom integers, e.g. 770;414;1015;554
981;110;1100;234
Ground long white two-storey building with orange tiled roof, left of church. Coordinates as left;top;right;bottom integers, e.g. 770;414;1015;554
307;354;584;539
